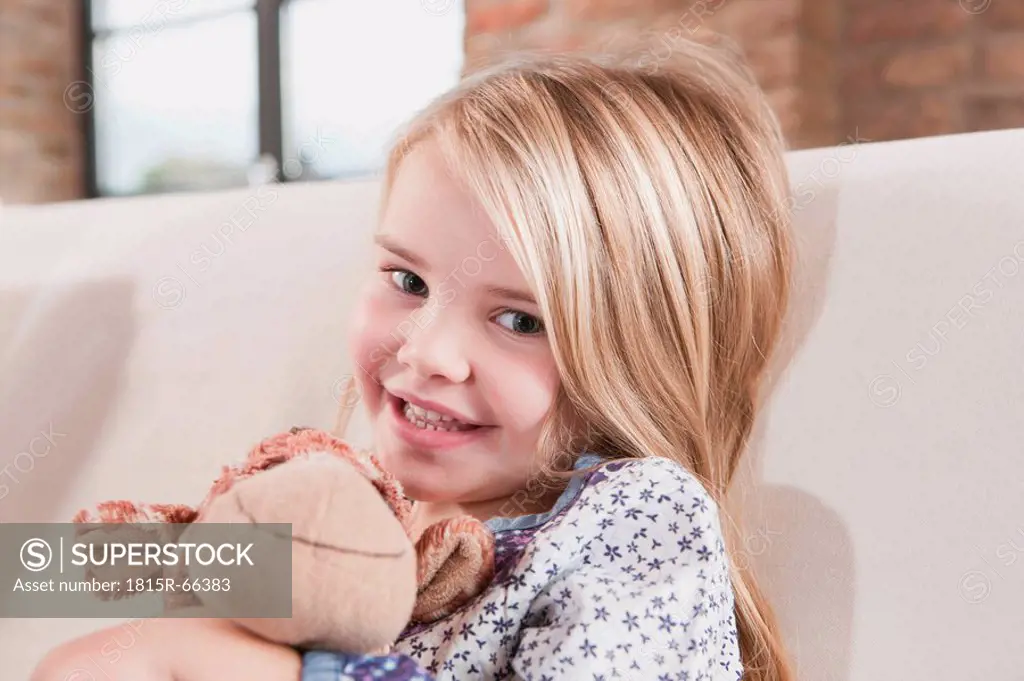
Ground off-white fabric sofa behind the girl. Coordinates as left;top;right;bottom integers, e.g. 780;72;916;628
0;125;1024;681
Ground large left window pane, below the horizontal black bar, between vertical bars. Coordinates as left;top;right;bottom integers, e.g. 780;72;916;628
93;12;259;195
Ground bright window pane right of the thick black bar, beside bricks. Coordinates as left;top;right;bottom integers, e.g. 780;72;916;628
282;0;464;179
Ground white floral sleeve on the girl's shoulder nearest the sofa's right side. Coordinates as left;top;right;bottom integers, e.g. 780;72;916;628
511;460;742;681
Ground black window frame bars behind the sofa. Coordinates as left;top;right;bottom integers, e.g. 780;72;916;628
80;0;291;199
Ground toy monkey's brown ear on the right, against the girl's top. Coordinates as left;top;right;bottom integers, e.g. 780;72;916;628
412;516;495;623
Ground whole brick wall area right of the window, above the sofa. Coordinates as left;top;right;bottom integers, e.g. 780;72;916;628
466;0;1024;148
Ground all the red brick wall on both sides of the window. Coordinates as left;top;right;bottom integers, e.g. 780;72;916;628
0;0;1024;203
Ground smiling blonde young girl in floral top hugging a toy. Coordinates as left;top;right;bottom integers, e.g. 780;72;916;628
36;39;792;681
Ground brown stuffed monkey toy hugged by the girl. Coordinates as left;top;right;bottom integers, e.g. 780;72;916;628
74;428;495;654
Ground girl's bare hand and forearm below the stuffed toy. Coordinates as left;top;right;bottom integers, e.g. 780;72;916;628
30;612;302;681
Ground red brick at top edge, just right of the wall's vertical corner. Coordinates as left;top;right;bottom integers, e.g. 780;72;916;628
846;0;972;44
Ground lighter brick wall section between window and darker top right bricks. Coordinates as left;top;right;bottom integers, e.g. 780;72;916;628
466;0;839;146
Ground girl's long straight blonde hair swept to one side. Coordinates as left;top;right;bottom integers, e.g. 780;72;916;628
383;42;793;681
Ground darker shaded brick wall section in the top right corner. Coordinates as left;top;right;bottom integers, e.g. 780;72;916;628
839;0;1024;139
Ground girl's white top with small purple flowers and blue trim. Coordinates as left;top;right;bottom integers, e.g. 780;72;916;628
302;454;742;681
